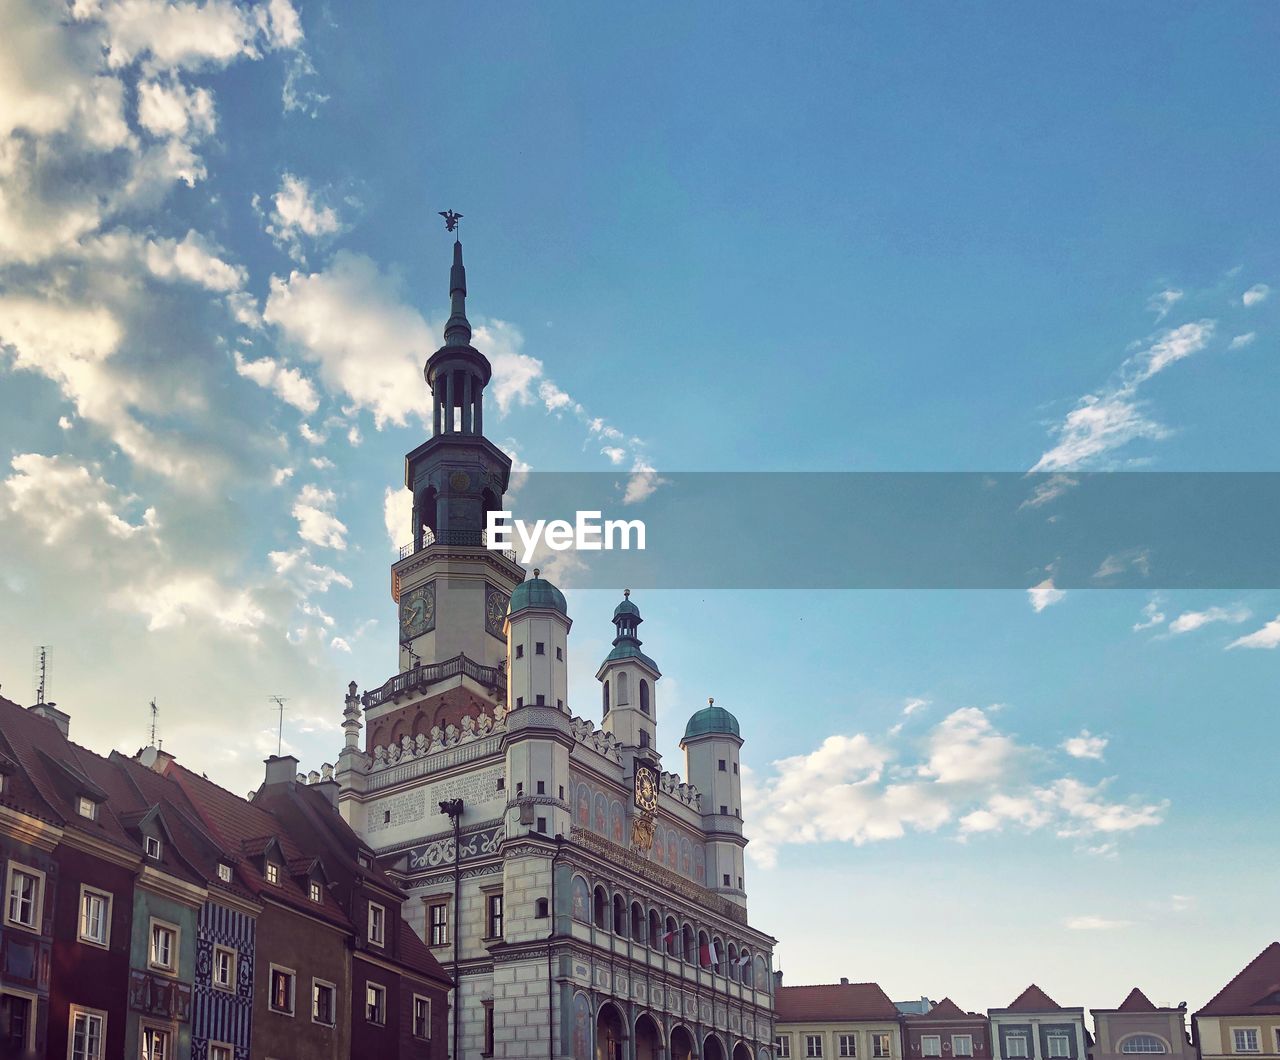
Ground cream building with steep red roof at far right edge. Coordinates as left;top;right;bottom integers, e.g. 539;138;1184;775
1192;942;1280;1060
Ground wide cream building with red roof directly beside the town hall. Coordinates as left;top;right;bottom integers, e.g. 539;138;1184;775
773;979;902;1060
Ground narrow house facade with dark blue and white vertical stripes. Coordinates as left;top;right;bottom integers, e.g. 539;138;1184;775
191;901;256;1060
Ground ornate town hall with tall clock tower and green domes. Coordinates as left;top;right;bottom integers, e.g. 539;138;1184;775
325;242;774;1060
